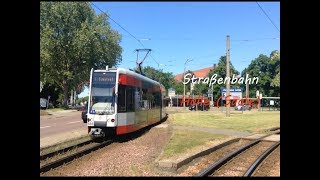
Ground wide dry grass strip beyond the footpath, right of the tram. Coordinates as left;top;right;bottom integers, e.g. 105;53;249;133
169;111;280;132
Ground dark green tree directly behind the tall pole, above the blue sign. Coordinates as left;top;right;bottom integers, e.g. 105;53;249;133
206;56;239;99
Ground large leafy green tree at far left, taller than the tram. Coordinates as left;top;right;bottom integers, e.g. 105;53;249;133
40;2;122;106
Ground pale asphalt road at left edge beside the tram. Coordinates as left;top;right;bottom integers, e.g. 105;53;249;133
40;111;87;138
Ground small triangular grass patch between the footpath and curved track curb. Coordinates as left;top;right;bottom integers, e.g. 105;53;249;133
160;130;227;159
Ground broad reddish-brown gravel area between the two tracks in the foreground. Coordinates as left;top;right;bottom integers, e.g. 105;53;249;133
40;125;175;176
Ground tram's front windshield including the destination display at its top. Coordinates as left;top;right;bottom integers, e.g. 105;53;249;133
89;72;116;115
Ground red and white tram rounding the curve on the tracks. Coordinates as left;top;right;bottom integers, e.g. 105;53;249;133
87;67;167;137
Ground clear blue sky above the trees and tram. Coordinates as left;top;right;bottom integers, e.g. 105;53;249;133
79;2;280;97
